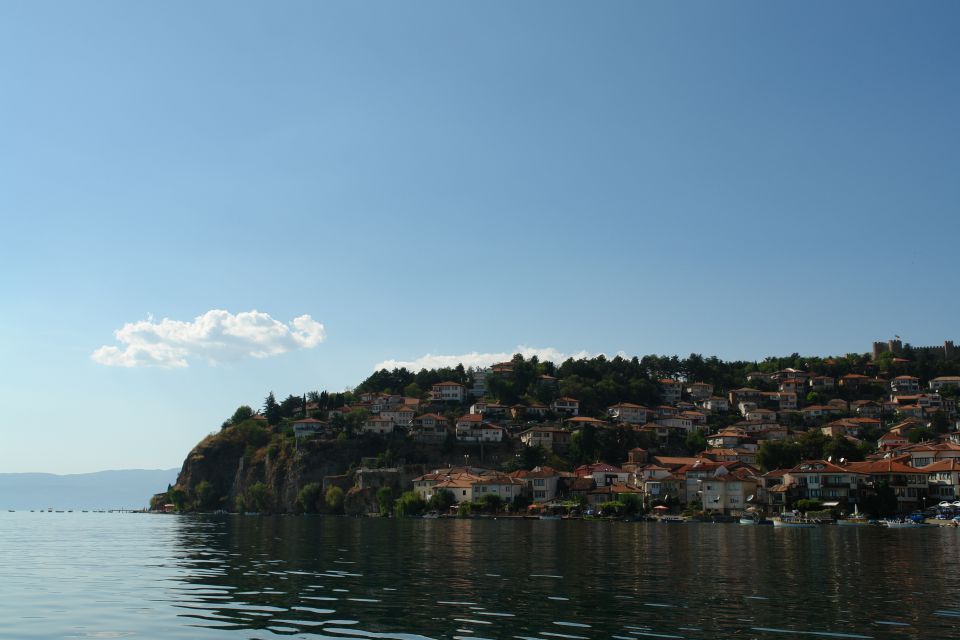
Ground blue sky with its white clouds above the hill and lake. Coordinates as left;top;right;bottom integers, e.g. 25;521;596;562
0;0;960;473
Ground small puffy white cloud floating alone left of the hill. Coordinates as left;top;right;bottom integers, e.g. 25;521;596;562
91;309;326;368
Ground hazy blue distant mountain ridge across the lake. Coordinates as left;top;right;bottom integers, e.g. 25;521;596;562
0;469;179;510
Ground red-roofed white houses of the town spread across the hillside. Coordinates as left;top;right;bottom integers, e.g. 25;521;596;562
231;341;960;515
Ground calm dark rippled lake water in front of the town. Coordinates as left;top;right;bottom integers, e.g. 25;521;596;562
0;512;960;640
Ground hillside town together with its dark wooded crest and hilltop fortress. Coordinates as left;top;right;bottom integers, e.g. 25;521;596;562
161;340;960;517
